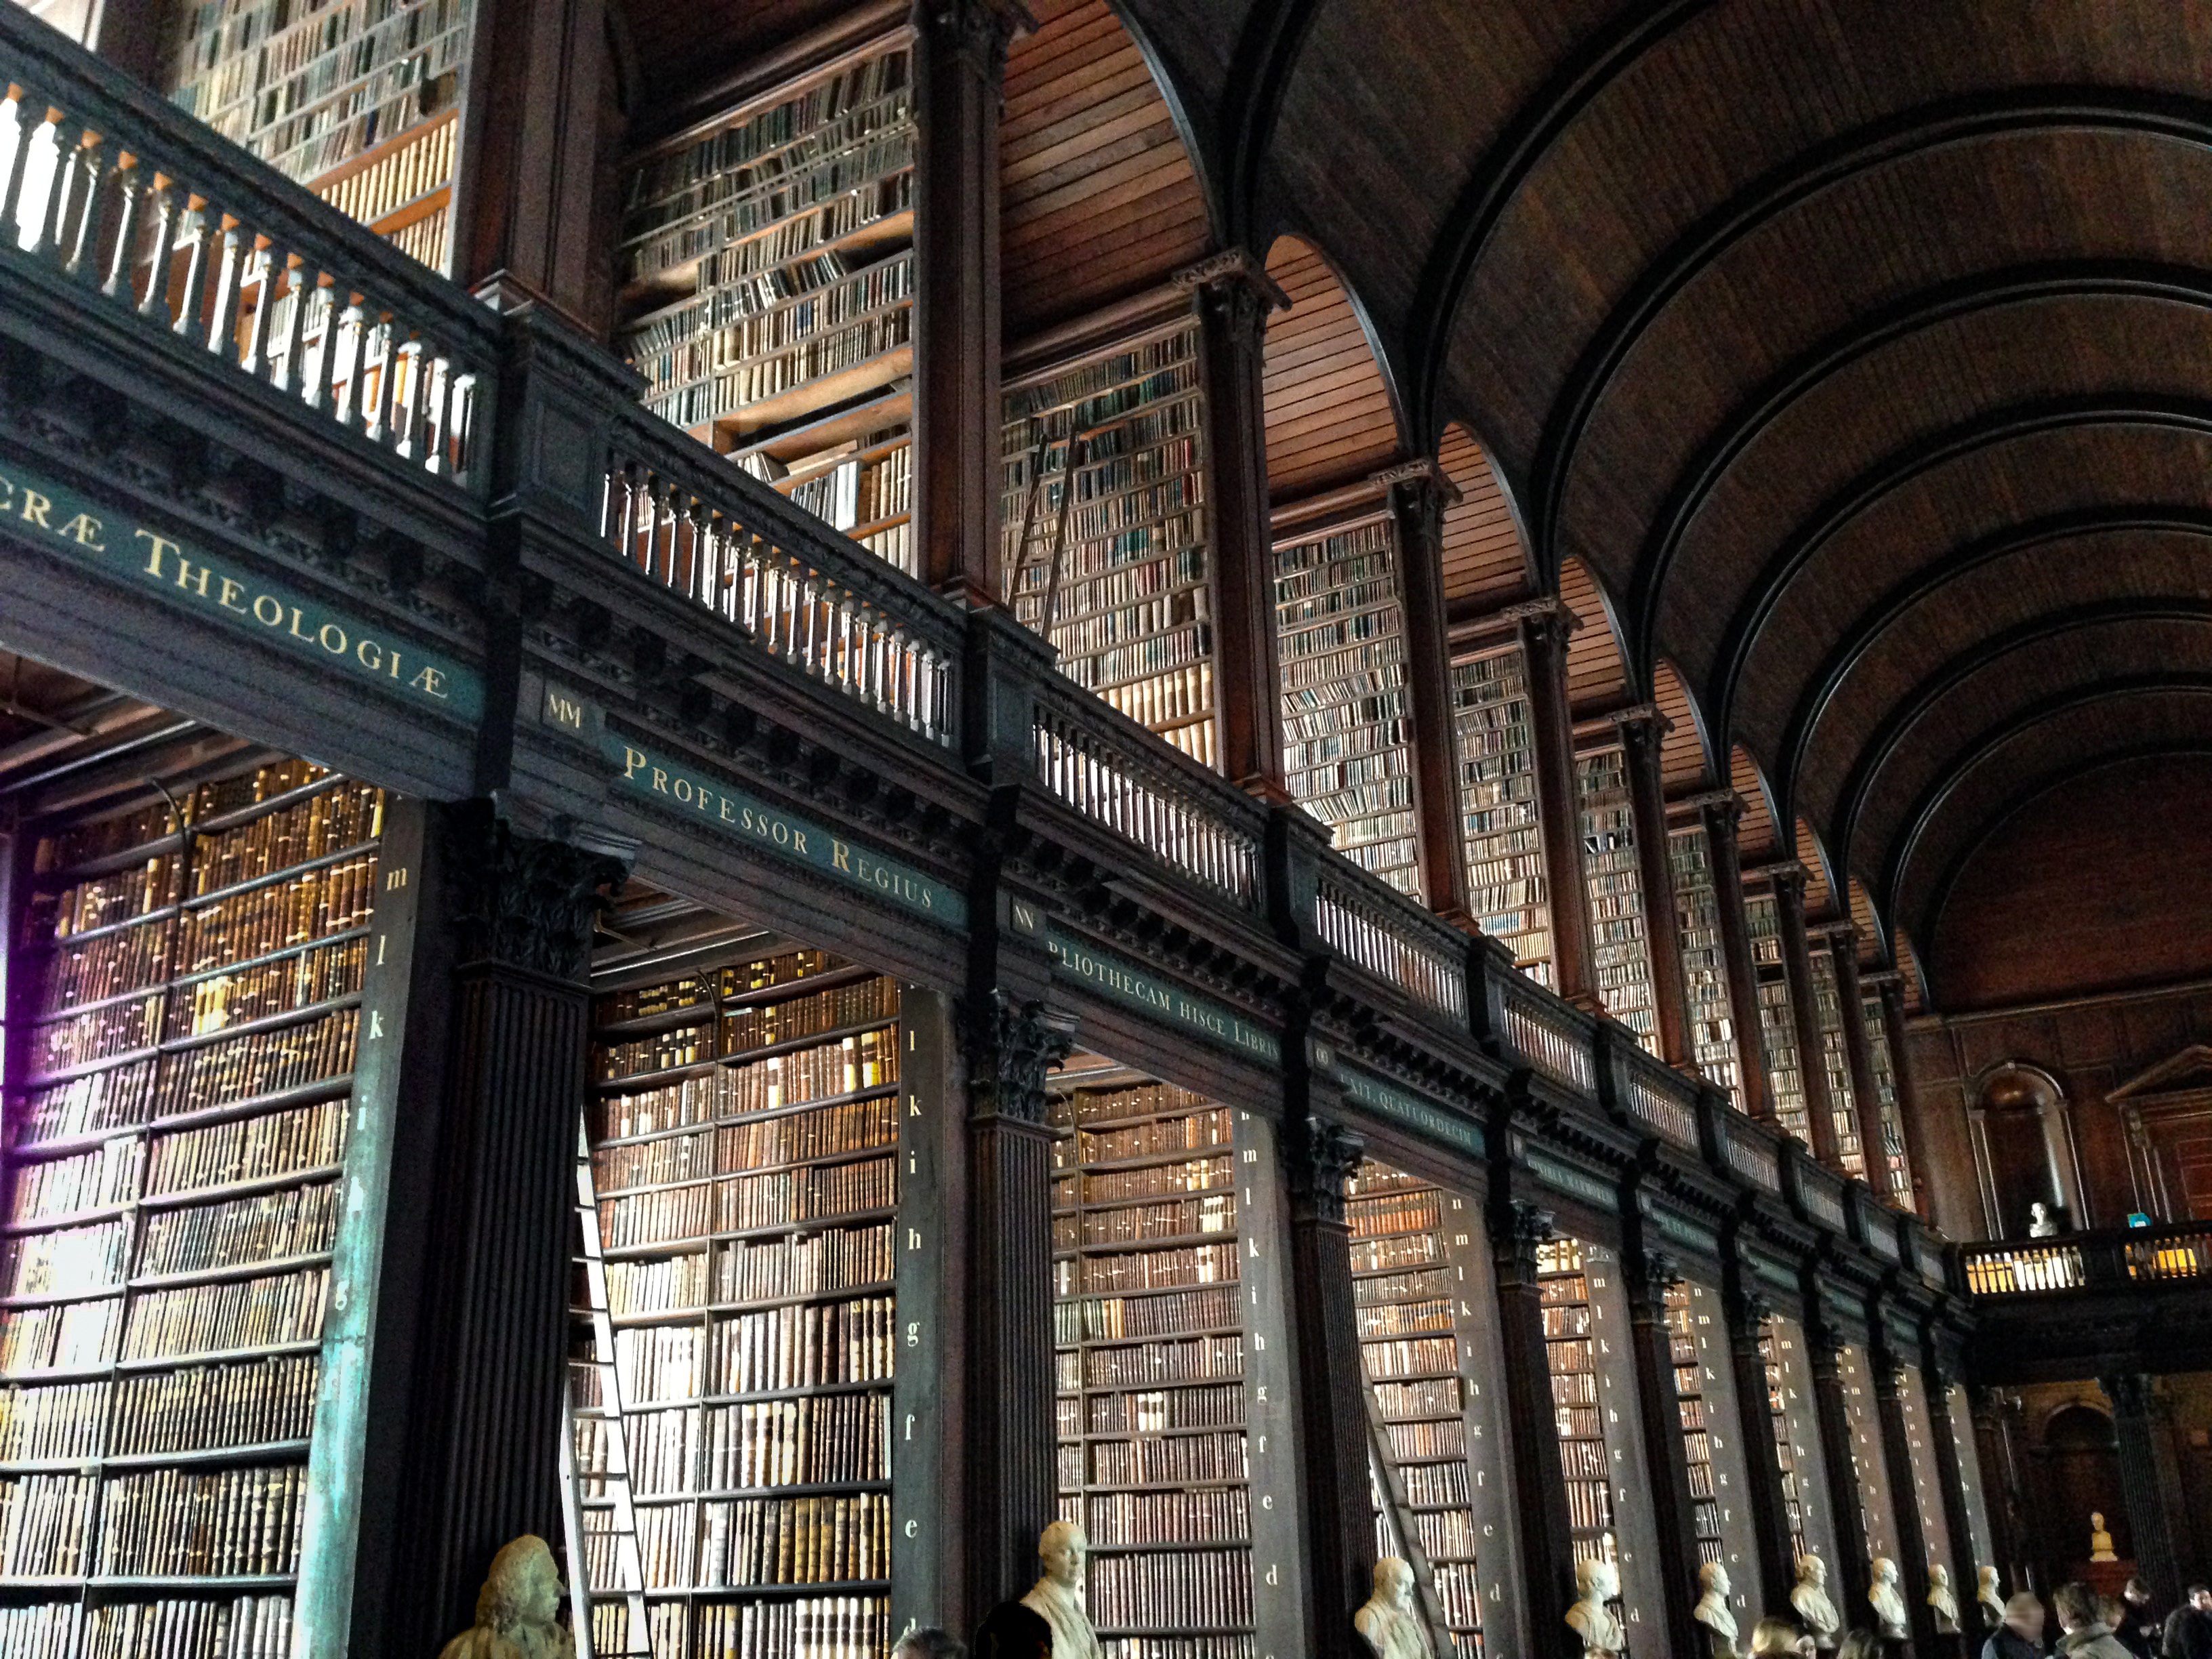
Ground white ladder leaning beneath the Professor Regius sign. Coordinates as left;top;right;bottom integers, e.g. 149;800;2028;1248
564;1113;653;1659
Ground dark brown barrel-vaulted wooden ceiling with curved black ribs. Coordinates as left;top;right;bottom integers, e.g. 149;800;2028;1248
1097;0;2212;982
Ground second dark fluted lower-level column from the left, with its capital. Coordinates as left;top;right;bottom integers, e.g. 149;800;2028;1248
962;991;1075;1619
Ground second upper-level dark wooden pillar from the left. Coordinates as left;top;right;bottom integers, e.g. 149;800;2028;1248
914;0;1031;606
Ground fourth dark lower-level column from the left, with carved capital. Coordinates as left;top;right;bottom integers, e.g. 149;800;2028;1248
1489;1199;1579;1659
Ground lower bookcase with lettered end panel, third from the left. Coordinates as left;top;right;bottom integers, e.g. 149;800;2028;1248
1050;1057;1298;1659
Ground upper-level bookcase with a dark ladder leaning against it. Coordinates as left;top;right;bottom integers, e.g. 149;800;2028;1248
998;312;1218;765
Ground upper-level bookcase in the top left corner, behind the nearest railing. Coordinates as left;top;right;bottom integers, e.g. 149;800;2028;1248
166;0;476;272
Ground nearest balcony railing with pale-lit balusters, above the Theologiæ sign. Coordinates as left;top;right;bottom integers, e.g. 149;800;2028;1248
0;7;500;495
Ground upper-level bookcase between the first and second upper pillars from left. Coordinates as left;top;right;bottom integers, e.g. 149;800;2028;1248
615;35;918;575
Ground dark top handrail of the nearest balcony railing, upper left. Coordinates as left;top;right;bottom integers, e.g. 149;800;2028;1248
0;7;500;352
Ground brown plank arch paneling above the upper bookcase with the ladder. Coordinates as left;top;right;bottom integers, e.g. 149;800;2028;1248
998;0;1210;341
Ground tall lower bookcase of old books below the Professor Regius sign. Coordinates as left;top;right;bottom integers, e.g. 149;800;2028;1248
571;949;907;1659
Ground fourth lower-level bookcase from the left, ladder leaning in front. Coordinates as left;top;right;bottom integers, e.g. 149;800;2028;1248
1345;1159;1507;1659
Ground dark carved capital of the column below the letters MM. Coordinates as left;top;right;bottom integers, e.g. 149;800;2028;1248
445;801;628;980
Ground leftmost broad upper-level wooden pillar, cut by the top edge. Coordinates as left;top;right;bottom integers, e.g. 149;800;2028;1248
451;0;621;321
